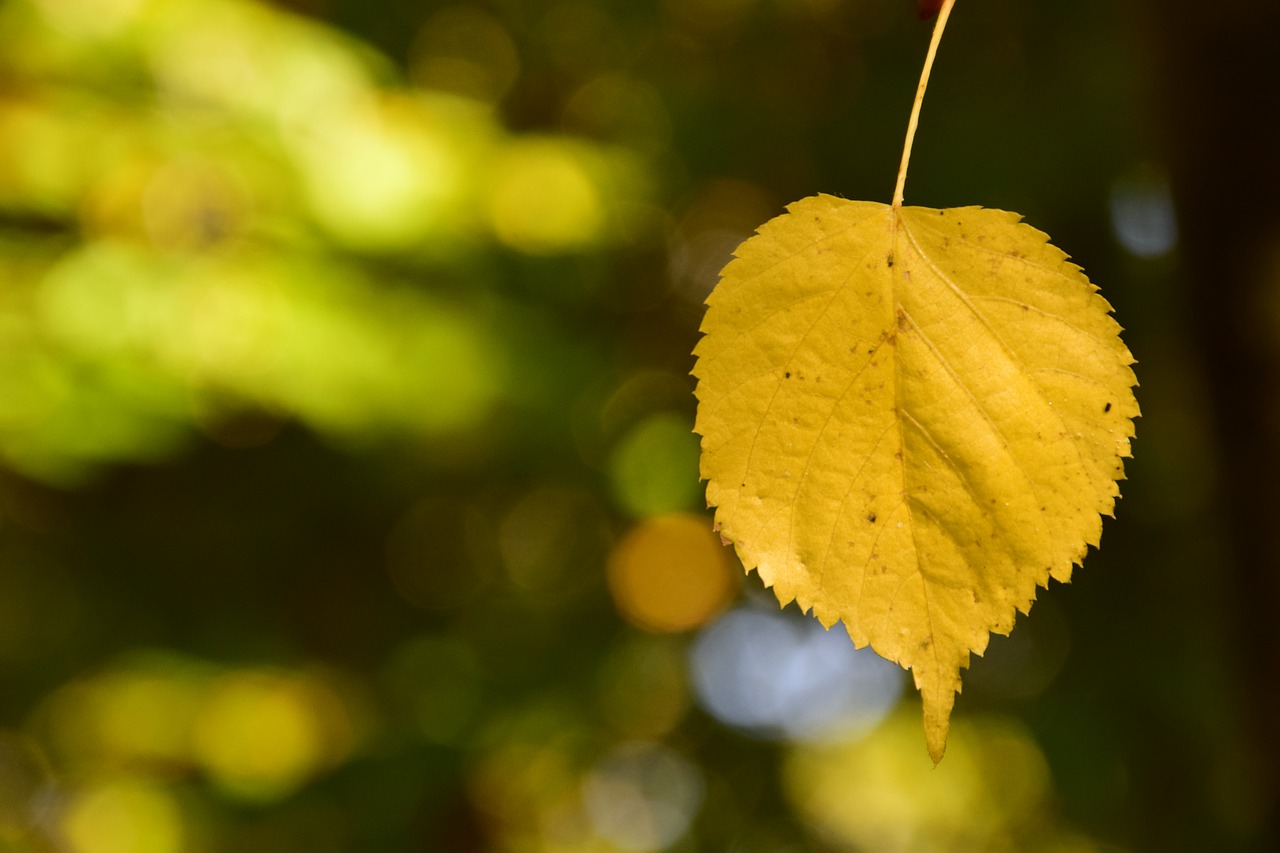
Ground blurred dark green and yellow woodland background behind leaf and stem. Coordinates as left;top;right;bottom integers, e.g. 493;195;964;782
0;0;1280;853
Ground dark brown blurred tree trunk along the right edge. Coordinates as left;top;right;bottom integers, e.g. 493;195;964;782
1146;0;1280;835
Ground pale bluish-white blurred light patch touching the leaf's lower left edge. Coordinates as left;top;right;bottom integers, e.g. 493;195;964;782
690;606;904;740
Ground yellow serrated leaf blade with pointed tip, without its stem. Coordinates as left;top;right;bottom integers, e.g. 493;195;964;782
694;196;1138;762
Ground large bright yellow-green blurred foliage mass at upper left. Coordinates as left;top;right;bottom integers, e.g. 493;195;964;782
0;0;646;483
